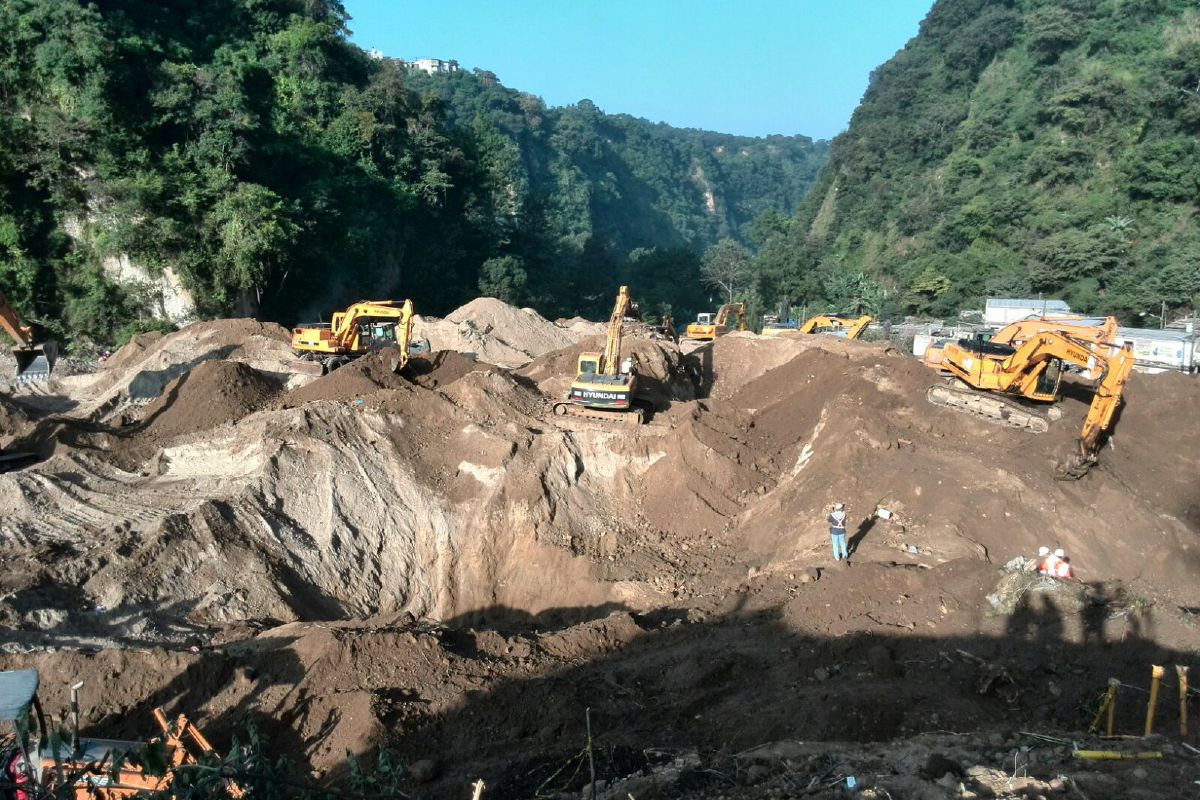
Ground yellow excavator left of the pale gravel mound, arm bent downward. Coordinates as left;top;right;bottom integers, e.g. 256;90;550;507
292;300;413;373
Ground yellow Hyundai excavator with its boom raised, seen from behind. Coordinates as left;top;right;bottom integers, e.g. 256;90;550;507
554;287;644;425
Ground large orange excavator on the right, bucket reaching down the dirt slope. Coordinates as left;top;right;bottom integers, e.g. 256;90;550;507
925;331;1134;480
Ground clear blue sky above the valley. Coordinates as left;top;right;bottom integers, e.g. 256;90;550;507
343;0;932;138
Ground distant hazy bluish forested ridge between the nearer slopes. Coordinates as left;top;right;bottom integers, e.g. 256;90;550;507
408;70;828;252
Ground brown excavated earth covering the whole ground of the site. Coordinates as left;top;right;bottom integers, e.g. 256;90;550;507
0;309;1200;800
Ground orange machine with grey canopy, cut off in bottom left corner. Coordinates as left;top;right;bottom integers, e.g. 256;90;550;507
0;669;245;800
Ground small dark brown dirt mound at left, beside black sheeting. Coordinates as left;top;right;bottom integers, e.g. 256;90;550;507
140;361;282;440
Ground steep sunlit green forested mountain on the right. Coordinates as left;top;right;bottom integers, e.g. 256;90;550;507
758;0;1200;325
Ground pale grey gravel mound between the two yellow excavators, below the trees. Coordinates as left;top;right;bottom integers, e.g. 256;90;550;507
413;297;590;367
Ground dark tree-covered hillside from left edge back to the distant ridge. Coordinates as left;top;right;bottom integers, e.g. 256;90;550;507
0;0;824;342
